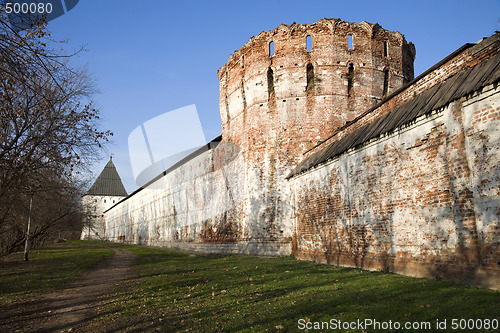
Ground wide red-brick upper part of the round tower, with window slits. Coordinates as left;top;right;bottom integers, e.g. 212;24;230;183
218;19;415;151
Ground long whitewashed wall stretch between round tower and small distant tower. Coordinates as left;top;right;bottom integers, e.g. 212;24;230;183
105;143;245;246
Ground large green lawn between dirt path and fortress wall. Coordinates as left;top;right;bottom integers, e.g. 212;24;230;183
91;247;500;332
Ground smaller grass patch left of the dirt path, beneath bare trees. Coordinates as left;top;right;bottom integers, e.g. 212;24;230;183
0;241;113;306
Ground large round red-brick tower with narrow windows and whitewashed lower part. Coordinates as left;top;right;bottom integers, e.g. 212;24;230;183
218;19;415;252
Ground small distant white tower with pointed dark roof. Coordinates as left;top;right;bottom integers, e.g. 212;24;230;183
81;156;127;239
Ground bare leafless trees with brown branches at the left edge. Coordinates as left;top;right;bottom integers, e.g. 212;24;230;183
0;7;112;252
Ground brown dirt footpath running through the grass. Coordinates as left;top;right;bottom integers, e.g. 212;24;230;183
0;249;135;332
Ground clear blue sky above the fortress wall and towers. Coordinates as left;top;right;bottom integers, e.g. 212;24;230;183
48;0;500;193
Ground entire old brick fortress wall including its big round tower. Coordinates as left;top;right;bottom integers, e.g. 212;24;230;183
104;19;500;288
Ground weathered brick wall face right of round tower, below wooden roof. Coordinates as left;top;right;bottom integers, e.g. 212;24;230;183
293;87;500;288
